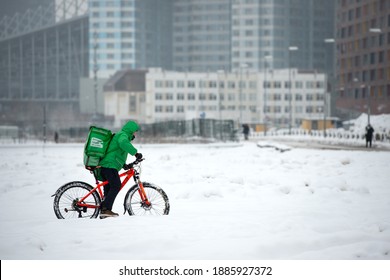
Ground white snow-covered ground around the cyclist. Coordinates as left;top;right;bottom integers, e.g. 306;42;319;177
0;142;390;260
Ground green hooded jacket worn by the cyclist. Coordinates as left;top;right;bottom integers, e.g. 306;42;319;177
99;121;139;171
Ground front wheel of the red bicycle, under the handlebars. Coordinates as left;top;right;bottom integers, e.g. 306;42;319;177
124;182;170;216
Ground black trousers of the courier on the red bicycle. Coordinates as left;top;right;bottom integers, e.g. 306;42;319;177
100;167;121;210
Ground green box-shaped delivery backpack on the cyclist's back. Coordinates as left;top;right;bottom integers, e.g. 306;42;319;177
84;126;114;171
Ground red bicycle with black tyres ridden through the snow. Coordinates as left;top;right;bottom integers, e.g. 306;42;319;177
52;159;170;219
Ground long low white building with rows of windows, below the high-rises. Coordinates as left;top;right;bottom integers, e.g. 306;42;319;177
105;68;330;128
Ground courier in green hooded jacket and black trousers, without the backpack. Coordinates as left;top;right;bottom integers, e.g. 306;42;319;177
99;121;142;218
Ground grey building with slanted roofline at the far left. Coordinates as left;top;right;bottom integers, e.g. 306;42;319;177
0;1;88;132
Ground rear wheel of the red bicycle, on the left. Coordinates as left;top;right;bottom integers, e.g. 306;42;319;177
53;181;101;219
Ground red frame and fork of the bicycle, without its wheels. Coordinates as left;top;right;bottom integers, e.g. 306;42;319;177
76;168;151;208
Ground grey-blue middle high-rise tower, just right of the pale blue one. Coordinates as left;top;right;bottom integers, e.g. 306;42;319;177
173;0;232;72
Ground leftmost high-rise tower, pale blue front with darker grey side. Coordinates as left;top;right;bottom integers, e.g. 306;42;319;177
89;0;172;78
